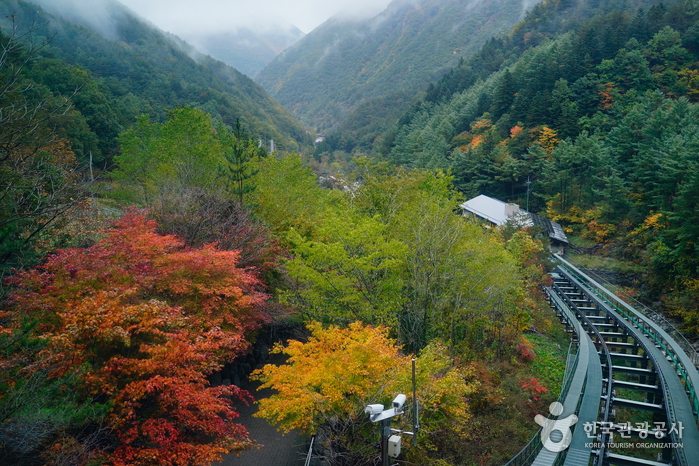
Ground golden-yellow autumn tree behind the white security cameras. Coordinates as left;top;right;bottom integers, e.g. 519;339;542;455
253;322;478;464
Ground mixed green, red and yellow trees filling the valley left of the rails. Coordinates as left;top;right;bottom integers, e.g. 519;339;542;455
0;45;561;466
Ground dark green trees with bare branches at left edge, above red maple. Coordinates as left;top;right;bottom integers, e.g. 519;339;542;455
0;23;85;276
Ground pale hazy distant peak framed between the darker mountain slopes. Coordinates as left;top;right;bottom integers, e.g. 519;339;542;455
183;27;305;77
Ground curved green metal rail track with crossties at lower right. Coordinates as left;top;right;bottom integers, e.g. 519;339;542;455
506;255;699;466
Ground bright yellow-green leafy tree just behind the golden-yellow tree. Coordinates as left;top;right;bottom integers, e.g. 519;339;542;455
286;212;407;326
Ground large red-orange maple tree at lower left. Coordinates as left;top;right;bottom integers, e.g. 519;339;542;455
0;212;266;466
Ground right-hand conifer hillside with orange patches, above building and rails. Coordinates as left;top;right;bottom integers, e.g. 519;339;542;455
378;2;699;332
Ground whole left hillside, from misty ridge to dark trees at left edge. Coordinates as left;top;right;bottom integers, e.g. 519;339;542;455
0;0;309;273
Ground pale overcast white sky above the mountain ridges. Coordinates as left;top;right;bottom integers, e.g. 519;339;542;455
120;0;390;35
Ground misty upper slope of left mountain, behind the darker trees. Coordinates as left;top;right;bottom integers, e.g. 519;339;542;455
0;0;307;160
